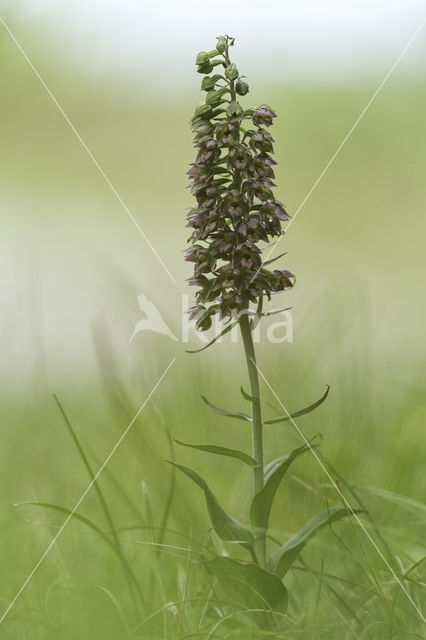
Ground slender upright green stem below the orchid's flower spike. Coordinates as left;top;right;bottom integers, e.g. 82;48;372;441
239;312;266;567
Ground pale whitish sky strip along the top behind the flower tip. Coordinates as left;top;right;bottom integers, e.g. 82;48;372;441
0;0;426;89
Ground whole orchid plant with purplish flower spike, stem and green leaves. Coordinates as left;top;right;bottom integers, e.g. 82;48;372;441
172;36;354;626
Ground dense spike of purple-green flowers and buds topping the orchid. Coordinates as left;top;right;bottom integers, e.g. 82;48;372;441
186;36;294;331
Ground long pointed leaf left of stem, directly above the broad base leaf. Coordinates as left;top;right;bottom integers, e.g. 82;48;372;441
168;460;254;552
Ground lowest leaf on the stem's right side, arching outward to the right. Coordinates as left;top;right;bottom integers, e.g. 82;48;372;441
268;507;360;578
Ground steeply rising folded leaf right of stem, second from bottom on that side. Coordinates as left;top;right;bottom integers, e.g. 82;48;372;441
250;445;309;530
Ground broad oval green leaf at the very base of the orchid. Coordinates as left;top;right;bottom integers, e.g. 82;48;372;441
203;557;288;626
